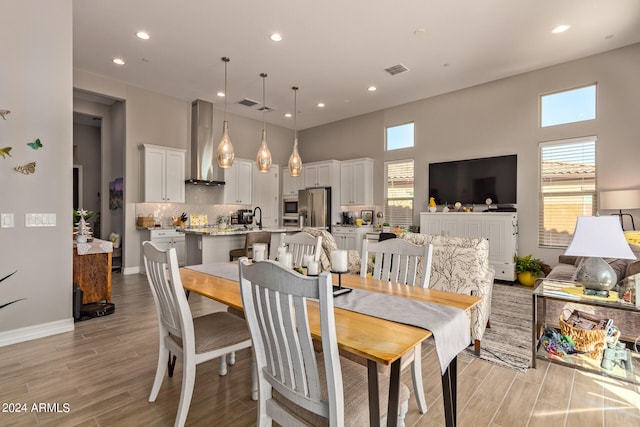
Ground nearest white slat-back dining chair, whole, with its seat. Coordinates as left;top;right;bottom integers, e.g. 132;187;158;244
239;258;409;427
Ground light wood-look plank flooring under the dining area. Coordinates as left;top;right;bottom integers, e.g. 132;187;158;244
0;274;640;427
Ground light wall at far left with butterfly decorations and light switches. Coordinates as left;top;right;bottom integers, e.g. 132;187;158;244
0;0;73;346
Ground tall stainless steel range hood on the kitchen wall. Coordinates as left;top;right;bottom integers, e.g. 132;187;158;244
185;99;224;185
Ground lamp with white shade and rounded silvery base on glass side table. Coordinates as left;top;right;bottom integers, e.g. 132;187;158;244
565;216;636;291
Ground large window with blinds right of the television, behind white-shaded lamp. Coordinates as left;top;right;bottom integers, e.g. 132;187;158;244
538;137;598;248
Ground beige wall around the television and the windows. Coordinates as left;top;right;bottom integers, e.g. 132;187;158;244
299;44;640;265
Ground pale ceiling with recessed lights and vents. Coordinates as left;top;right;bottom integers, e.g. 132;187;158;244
73;0;640;129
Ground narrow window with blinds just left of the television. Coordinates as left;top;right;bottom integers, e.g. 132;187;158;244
384;160;413;228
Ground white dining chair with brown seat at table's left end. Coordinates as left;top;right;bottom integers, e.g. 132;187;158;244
142;242;257;426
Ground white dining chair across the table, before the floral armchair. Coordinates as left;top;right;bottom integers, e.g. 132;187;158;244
360;239;433;414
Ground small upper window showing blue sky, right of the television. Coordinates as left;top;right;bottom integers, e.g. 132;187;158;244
540;85;596;127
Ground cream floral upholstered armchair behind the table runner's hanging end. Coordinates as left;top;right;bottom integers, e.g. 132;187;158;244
402;233;495;354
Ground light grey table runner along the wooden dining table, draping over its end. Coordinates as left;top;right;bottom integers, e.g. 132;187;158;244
186;262;471;374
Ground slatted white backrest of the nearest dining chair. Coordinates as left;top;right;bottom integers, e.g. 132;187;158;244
239;258;344;421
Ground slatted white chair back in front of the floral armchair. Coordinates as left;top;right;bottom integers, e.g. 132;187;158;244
360;239;433;287
